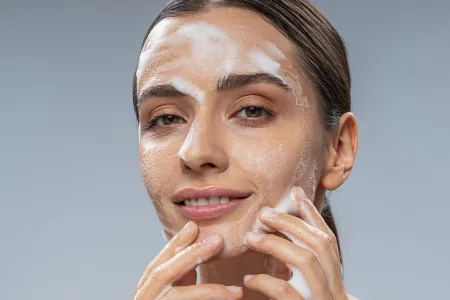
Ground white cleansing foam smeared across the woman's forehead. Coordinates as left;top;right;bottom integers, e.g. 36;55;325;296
136;22;292;100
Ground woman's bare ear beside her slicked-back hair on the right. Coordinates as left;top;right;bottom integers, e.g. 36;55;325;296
321;112;358;191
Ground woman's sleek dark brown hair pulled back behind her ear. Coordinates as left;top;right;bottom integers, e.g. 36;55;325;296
133;0;351;274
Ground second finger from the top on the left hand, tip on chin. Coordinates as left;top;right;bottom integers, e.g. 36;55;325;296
138;234;223;300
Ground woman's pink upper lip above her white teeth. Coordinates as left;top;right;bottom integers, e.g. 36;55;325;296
173;187;251;204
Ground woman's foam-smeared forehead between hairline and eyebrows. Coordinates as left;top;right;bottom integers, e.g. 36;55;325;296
136;7;298;94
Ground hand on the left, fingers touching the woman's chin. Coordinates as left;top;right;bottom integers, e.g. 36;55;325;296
133;221;243;300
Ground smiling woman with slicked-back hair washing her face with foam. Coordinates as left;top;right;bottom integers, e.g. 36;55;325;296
133;0;358;300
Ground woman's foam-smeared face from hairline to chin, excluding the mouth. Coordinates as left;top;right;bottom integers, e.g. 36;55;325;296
136;8;323;257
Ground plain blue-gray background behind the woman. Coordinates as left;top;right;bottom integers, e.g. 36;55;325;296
0;0;450;300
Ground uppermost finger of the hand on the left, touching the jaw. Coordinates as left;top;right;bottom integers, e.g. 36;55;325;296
133;221;198;297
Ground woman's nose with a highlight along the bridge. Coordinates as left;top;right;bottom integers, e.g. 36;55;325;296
178;121;228;173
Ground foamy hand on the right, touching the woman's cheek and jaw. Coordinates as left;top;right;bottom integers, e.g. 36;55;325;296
244;187;355;300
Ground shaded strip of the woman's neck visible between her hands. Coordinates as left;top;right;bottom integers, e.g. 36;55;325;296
199;251;269;300
